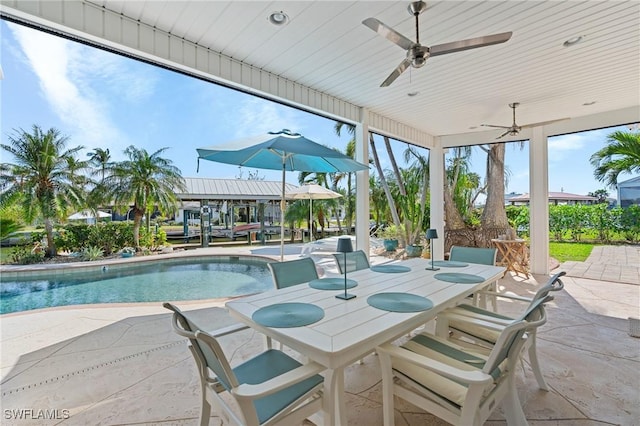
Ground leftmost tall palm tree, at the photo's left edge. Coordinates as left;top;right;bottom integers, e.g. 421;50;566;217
0;125;85;257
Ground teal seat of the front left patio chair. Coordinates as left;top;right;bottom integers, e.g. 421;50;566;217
233;349;323;424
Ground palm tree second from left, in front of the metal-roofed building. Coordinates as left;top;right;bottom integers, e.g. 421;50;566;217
100;145;186;248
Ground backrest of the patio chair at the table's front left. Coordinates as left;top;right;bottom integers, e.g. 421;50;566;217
162;302;238;390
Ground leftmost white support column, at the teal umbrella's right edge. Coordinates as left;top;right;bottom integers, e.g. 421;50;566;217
354;109;369;257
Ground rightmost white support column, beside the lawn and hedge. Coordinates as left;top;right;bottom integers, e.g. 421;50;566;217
529;127;549;275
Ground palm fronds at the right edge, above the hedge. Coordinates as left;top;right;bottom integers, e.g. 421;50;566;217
591;130;640;187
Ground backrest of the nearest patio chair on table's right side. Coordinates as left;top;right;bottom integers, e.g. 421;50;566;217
483;298;547;377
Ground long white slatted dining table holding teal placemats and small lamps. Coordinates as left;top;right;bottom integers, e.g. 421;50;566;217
226;258;505;426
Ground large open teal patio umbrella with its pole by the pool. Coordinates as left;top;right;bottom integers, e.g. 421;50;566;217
197;129;368;261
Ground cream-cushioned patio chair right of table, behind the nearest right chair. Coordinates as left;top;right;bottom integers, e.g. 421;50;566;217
436;271;566;391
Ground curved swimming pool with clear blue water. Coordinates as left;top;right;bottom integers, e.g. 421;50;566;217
0;256;274;314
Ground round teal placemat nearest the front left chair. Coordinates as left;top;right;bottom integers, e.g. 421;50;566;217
251;303;324;328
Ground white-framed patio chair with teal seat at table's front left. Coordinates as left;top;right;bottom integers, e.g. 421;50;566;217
163;303;324;426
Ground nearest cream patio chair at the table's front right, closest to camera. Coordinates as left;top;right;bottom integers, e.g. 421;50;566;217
377;300;546;426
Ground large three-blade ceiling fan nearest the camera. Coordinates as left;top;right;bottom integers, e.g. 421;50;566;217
362;1;512;87
